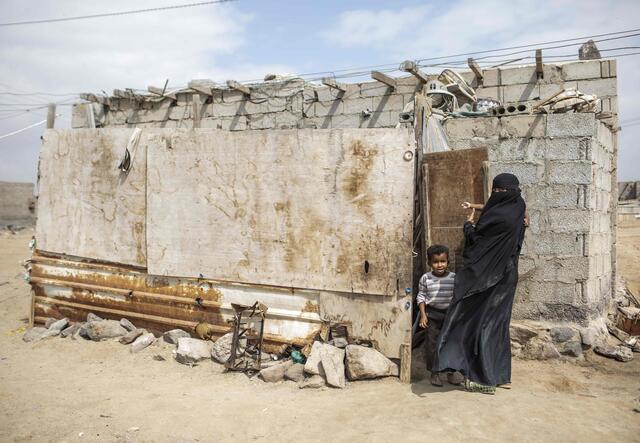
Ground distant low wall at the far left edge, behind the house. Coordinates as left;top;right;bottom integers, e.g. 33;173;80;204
0;182;36;227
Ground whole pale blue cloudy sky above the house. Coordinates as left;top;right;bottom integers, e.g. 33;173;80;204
0;0;640;182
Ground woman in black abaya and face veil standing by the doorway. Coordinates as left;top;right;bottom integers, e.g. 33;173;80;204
434;174;526;393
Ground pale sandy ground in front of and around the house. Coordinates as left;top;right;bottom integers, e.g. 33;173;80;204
0;223;640;442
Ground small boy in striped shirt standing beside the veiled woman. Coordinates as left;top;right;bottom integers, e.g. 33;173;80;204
416;245;460;386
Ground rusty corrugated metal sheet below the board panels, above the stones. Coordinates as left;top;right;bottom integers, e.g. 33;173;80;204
31;251;322;350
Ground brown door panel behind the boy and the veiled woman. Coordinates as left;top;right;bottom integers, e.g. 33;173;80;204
425;148;488;270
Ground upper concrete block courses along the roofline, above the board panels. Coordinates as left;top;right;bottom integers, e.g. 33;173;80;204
72;60;617;131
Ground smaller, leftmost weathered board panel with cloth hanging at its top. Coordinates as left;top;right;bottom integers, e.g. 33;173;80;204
36;129;146;266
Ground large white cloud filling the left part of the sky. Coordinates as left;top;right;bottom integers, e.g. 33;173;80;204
0;0;293;181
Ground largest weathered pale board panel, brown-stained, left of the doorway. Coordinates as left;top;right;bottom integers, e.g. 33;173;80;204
147;128;414;295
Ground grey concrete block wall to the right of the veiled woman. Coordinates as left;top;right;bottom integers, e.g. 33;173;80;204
444;113;616;324
